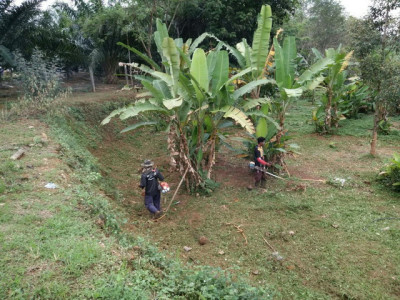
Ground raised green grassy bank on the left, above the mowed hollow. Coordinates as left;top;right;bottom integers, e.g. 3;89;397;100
0;98;271;299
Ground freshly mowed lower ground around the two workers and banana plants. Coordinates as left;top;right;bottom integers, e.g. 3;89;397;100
93;102;400;299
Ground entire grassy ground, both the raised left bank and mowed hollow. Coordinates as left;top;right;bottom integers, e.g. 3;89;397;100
0;86;400;299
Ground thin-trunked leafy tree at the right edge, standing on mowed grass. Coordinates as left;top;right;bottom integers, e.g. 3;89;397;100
351;0;400;155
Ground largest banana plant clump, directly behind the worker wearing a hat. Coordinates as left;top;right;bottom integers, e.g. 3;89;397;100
102;21;268;189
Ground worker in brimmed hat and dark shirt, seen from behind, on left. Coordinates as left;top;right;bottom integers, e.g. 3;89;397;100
139;159;164;218
